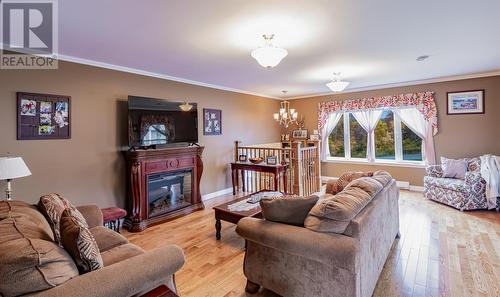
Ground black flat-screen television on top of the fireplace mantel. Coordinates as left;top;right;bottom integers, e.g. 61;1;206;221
128;96;198;148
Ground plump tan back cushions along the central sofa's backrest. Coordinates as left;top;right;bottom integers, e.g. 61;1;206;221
304;171;392;233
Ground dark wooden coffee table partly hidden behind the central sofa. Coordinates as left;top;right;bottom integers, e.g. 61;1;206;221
214;190;270;240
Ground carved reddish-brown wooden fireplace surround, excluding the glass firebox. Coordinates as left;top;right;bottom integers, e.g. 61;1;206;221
124;146;204;232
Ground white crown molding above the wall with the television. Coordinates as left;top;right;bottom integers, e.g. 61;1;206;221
56;54;280;100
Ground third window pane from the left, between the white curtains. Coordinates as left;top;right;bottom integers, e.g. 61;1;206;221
375;110;396;160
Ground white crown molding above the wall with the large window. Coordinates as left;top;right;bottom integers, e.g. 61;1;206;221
287;69;500;100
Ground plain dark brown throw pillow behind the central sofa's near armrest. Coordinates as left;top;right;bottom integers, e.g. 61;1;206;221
260;195;319;226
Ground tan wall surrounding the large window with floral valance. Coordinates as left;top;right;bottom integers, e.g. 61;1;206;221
291;76;500;186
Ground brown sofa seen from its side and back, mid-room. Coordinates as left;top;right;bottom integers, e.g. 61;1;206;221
236;173;399;297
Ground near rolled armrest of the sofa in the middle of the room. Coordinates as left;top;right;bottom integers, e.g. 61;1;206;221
236;218;359;271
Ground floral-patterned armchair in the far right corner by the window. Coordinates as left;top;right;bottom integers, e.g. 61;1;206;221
424;158;488;211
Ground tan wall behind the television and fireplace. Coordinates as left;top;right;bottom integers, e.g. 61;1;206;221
0;62;280;207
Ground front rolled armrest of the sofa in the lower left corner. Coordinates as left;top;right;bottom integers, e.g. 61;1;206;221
27;245;184;297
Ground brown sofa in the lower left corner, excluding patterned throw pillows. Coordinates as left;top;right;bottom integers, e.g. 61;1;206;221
0;201;184;297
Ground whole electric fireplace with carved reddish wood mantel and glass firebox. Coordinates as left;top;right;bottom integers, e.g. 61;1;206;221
124;146;204;232
